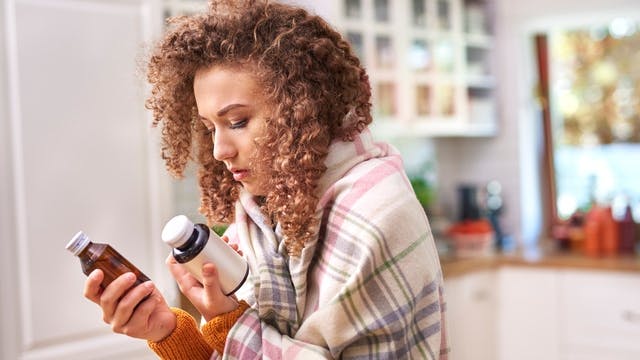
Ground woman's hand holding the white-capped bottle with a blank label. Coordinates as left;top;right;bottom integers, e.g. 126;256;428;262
167;254;238;321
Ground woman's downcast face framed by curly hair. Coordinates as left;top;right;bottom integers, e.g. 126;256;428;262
193;66;269;195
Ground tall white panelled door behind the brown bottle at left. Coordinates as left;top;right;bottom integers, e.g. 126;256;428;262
0;0;167;359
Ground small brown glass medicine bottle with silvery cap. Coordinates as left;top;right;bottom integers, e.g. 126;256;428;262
66;231;149;288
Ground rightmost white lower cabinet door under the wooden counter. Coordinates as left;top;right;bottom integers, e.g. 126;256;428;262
560;271;640;360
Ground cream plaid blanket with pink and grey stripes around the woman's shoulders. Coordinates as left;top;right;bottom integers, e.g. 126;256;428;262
218;130;448;359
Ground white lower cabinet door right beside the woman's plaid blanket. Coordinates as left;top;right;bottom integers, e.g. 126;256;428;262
445;271;497;360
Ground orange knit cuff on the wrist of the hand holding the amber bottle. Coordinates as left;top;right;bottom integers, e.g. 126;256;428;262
147;308;213;360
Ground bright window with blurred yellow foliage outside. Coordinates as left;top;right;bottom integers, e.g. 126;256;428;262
537;19;640;222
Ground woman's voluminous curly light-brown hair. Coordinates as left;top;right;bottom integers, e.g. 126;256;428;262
146;0;371;255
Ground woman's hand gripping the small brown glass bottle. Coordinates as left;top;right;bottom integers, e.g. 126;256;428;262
84;269;176;342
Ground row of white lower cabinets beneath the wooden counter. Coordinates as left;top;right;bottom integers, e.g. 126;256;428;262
445;265;640;360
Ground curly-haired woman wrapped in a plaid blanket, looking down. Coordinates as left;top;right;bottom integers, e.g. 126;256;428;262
85;1;448;359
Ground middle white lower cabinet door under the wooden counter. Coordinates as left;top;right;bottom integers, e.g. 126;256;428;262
498;267;559;360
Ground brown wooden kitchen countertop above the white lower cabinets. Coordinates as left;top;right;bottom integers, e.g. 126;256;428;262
440;253;640;278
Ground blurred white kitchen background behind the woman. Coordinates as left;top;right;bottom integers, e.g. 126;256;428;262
0;0;640;360
